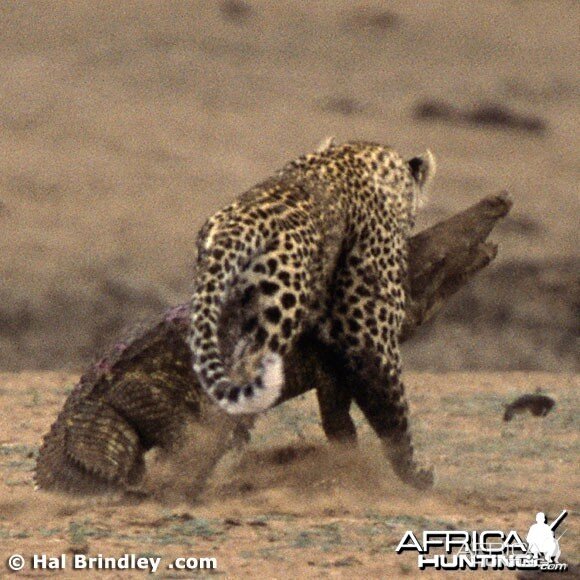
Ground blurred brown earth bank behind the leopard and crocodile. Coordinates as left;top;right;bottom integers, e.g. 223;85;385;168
0;0;580;372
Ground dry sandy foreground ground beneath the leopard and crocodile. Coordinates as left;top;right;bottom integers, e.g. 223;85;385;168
0;372;580;578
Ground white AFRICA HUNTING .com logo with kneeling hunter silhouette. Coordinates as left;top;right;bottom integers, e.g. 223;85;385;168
396;510;568;572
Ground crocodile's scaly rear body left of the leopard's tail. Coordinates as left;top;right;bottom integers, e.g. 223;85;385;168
35;308;203;493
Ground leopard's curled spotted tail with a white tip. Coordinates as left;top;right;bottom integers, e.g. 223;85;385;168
190;247;284;415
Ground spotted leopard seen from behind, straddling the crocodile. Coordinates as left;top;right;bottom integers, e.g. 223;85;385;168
189;139;436;488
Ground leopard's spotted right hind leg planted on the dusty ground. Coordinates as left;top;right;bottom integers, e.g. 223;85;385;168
323;254;433;489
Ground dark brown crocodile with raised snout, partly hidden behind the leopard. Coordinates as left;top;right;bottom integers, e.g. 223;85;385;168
35;194;511;494
